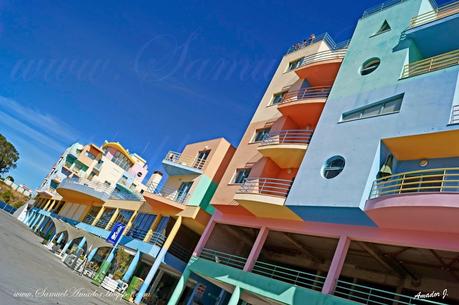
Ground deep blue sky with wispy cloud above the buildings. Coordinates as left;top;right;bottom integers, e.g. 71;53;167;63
0;0;440;188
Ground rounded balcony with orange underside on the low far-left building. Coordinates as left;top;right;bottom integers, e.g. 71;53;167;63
57;178;113;204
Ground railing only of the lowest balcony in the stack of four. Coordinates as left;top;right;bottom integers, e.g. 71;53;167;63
237;178;293;197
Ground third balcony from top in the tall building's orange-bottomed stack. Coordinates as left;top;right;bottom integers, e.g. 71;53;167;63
258;129;312;168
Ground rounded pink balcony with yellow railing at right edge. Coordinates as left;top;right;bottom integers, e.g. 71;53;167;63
365;168;459;233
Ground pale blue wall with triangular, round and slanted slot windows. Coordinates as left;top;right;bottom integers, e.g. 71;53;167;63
287;0;458;225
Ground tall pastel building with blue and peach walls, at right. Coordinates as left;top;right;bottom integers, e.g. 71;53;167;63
168;0;459;305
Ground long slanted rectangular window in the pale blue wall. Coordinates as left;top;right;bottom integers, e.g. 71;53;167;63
341;94;403;122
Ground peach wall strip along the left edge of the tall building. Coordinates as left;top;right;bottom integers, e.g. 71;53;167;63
212;41;329;205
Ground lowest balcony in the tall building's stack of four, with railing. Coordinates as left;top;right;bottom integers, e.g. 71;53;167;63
234;178;300;220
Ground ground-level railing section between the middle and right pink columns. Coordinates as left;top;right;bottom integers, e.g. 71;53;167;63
252;261;326;290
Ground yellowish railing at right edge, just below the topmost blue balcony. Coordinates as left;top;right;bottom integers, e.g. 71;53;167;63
401;50;459;78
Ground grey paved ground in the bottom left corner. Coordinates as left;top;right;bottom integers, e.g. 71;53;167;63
0;211;132;305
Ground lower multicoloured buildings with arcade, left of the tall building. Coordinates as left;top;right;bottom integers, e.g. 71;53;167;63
25;138;235;304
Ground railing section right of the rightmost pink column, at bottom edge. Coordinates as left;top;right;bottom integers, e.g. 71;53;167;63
334;280;447;305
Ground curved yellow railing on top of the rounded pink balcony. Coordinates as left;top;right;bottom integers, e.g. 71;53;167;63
370;168;459;199
